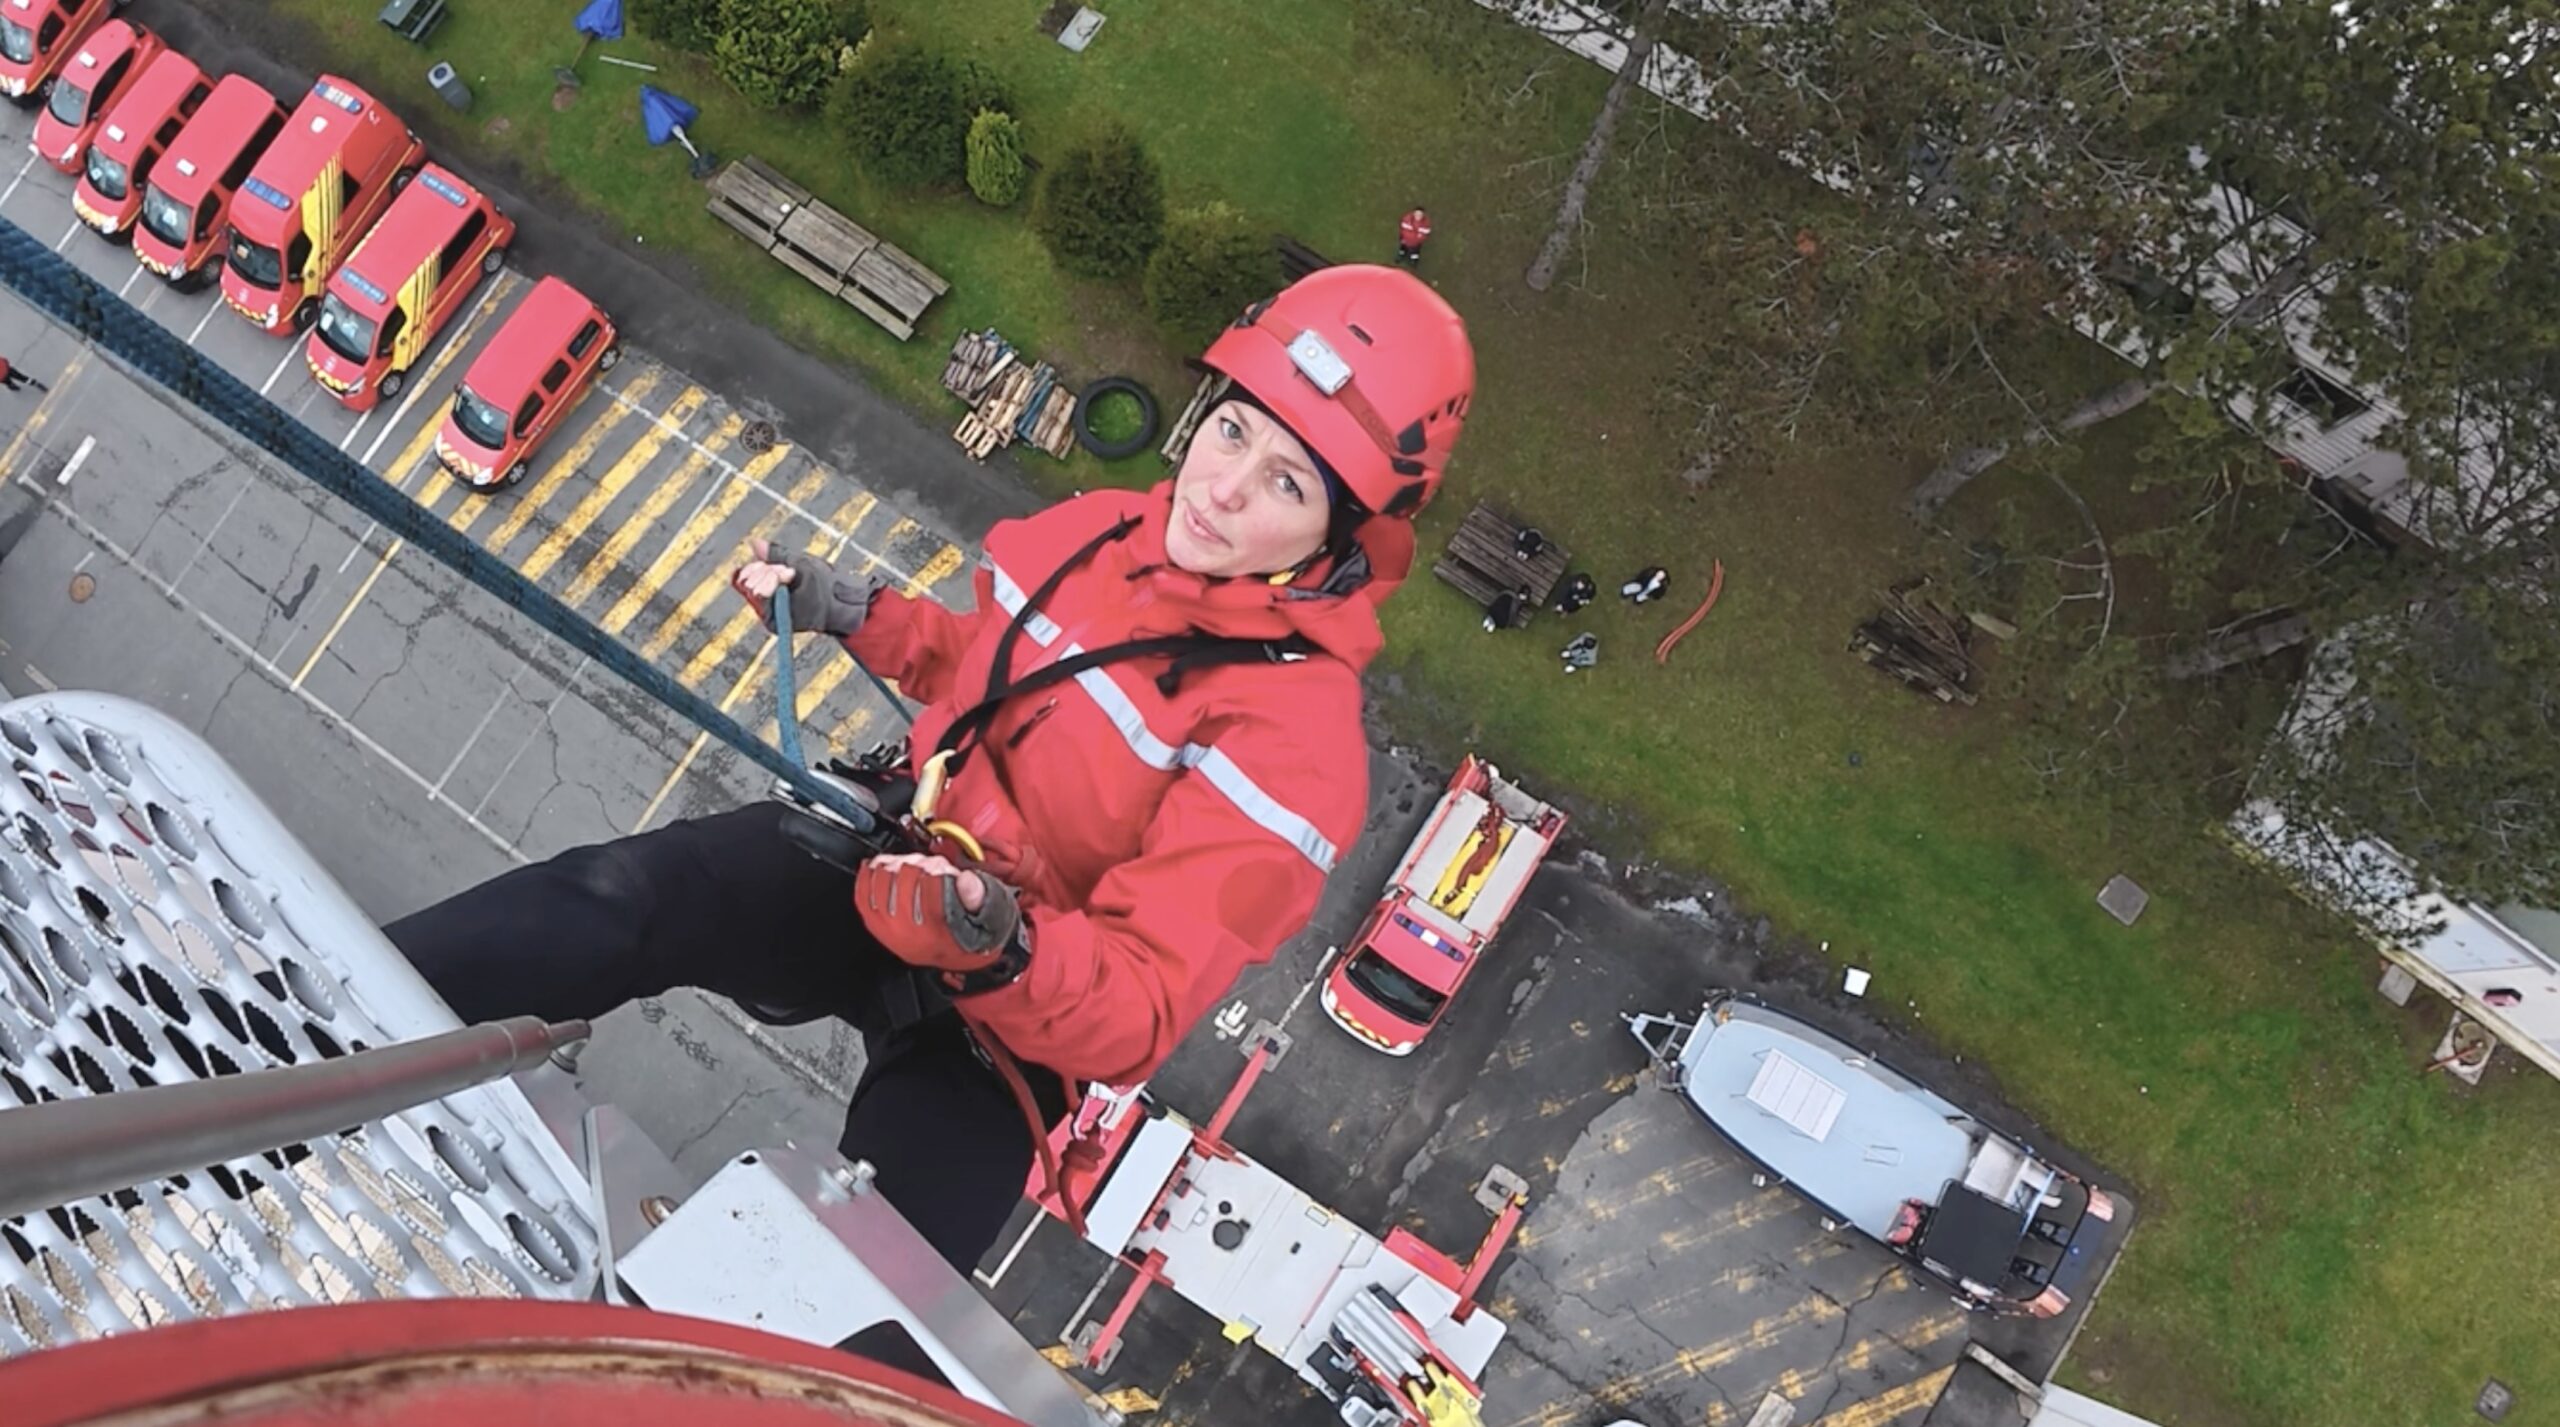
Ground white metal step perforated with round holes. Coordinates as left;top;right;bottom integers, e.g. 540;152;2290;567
0;694;596;1358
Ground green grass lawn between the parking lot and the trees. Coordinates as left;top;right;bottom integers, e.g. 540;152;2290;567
271;0;2560;1427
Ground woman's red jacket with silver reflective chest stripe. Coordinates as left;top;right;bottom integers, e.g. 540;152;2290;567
845;484;1413;1084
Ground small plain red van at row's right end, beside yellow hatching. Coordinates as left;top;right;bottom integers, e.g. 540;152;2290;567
435;277;622;489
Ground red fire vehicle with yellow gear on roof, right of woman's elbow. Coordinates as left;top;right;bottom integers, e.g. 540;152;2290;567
1321;753;1564;1056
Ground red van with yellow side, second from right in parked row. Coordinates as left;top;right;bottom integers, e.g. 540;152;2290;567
305;164;515;410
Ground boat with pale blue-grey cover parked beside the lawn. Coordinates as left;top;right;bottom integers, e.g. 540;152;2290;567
1628;991;2115;1317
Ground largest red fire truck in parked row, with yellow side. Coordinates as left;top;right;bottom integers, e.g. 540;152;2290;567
223;74;428;336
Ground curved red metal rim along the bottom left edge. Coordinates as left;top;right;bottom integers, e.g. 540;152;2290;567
0;1299;1019;1427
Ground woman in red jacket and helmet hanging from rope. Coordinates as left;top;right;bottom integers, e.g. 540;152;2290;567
389;266;1475;1266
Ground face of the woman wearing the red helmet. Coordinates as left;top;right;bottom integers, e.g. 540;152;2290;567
1165;402;1331;576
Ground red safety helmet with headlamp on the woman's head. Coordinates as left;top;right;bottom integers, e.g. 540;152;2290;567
1201;264;1475;518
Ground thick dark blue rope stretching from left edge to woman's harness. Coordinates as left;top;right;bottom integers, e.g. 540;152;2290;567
0;220;906;828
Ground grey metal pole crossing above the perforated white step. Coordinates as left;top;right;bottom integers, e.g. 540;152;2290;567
0;1015;589;1219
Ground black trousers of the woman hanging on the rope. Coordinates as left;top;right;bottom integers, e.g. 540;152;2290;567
387;802;1065;1271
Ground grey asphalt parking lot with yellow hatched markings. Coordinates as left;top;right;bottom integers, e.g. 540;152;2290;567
0;0;2125;1427
